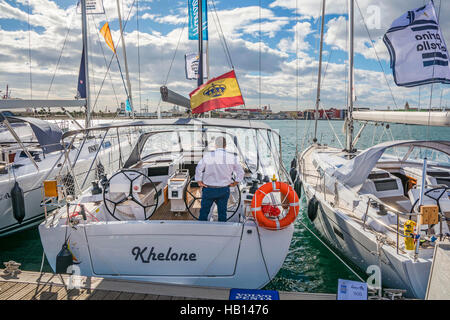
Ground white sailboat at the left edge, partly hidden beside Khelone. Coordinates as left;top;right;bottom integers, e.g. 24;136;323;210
0;1;136;236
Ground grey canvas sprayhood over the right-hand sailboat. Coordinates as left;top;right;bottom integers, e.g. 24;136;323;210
333;140;450;191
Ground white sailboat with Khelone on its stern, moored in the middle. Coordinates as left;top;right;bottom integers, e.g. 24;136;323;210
39;1;299;288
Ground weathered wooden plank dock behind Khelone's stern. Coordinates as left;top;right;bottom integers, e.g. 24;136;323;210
0;269;336;300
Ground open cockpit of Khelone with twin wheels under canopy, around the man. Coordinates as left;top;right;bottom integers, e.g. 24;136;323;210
65;122;289;222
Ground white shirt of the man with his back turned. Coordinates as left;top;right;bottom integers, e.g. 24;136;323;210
195;148;244;187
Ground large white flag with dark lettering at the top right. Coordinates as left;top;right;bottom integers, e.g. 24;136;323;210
383;1;450;87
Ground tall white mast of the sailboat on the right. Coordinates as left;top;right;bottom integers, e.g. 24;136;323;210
346;0;355;153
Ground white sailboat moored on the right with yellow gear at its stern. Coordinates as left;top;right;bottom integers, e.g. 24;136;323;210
293;0;450;298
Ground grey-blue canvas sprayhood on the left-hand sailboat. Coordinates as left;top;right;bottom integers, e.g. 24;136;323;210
7;116;62;153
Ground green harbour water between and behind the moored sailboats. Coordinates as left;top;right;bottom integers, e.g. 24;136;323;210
0;120;450;293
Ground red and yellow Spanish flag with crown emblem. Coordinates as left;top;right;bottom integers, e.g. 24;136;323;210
189;70;244;113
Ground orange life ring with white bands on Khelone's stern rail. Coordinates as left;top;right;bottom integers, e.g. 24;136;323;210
251;181;300;230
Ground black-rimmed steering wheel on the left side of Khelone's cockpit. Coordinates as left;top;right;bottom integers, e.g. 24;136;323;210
103;169;158;221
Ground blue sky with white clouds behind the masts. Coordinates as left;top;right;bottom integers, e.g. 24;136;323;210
0;0;450;112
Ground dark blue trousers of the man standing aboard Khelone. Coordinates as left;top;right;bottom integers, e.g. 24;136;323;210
199;186;230;222
